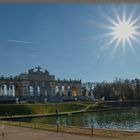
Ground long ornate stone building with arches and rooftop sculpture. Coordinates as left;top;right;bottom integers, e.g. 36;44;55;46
0;67;82;99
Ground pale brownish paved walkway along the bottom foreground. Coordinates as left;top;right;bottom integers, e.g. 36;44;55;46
0;125;140;140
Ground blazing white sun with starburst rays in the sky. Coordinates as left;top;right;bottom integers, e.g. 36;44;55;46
106;7;140;47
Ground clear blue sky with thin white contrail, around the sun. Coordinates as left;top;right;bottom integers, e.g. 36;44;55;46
0;3;140;82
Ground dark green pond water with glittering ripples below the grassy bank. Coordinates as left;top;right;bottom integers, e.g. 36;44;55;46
15;108;140;130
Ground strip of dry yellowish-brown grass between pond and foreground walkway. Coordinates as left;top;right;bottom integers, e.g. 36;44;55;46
0;121;140;138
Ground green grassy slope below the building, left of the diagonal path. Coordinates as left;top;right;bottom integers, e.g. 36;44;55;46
0;102;86;116
